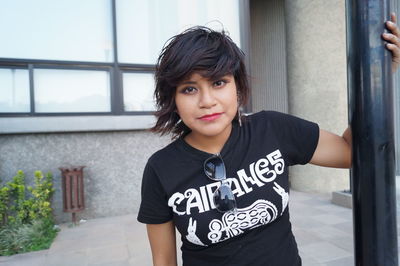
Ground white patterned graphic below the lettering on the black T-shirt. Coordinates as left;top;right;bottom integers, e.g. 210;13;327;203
186;182;289;246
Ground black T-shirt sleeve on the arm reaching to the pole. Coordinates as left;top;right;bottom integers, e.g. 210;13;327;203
266;111;319;165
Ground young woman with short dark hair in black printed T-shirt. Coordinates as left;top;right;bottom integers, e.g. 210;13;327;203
138;15;400;266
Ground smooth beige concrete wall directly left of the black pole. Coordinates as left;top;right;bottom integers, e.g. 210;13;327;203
285;0;349;192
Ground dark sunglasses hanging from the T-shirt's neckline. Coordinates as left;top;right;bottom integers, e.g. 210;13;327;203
204;154;236;213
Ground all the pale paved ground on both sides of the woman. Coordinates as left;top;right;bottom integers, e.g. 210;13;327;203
0;191;382;266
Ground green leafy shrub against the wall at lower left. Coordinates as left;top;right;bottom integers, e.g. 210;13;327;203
0;170;57;256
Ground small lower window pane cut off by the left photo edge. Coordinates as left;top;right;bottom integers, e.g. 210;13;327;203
0;69;30;113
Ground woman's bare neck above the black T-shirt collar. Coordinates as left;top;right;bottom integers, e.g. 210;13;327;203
184;124;232;154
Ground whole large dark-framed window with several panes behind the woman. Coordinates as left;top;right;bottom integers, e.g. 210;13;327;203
0;0;241;132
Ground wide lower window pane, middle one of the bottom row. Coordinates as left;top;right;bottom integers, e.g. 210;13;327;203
34;69;111;113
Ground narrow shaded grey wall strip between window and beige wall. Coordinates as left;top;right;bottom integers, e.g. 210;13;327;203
250;0;288;113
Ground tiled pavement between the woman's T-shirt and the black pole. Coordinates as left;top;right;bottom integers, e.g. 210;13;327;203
289;191;354;266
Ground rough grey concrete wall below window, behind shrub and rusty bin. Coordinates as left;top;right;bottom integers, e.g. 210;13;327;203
0;131;170;222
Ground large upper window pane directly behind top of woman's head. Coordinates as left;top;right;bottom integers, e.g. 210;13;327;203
116;0;240;64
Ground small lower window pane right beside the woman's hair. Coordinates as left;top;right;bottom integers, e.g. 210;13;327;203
123;73;156;111
